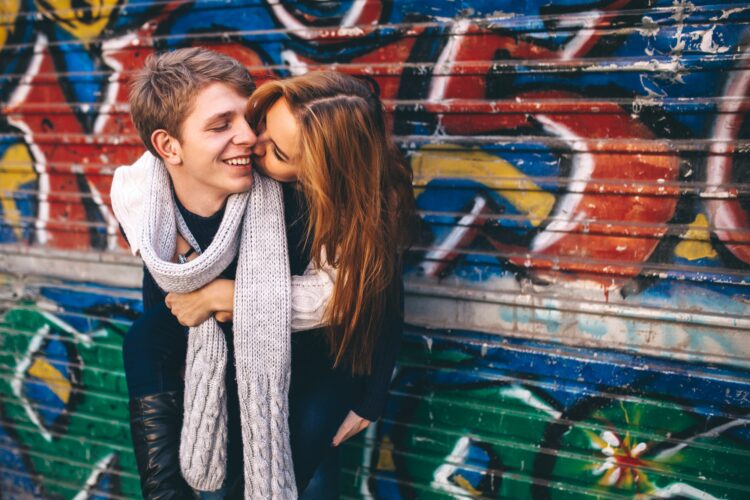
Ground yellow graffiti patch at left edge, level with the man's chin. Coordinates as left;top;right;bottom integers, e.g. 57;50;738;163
0;144;36;239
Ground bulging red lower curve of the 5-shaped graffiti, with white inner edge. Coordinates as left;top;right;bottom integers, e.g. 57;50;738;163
511;99;679;283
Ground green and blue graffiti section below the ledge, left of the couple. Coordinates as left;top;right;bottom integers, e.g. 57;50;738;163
0;282;140;499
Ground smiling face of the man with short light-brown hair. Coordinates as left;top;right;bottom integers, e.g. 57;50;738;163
170;82;256;205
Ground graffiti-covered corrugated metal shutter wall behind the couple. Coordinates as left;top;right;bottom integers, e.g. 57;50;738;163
0;0;750;499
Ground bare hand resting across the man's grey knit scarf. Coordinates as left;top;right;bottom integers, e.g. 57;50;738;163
165;279;234;326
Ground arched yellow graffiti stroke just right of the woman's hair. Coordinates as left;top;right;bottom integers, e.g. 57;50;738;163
411;144;555;226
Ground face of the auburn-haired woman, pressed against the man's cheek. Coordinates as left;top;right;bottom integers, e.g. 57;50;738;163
252;97;299;182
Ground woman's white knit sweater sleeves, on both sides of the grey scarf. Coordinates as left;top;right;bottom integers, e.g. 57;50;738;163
110;152;336;332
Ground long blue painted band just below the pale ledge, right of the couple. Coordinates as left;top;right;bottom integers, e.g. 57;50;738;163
406;327;750;413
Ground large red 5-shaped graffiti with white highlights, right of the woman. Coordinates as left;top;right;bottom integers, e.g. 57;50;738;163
426;25;679;284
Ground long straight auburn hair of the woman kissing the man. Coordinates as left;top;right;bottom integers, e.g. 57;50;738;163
247;71;415;375
